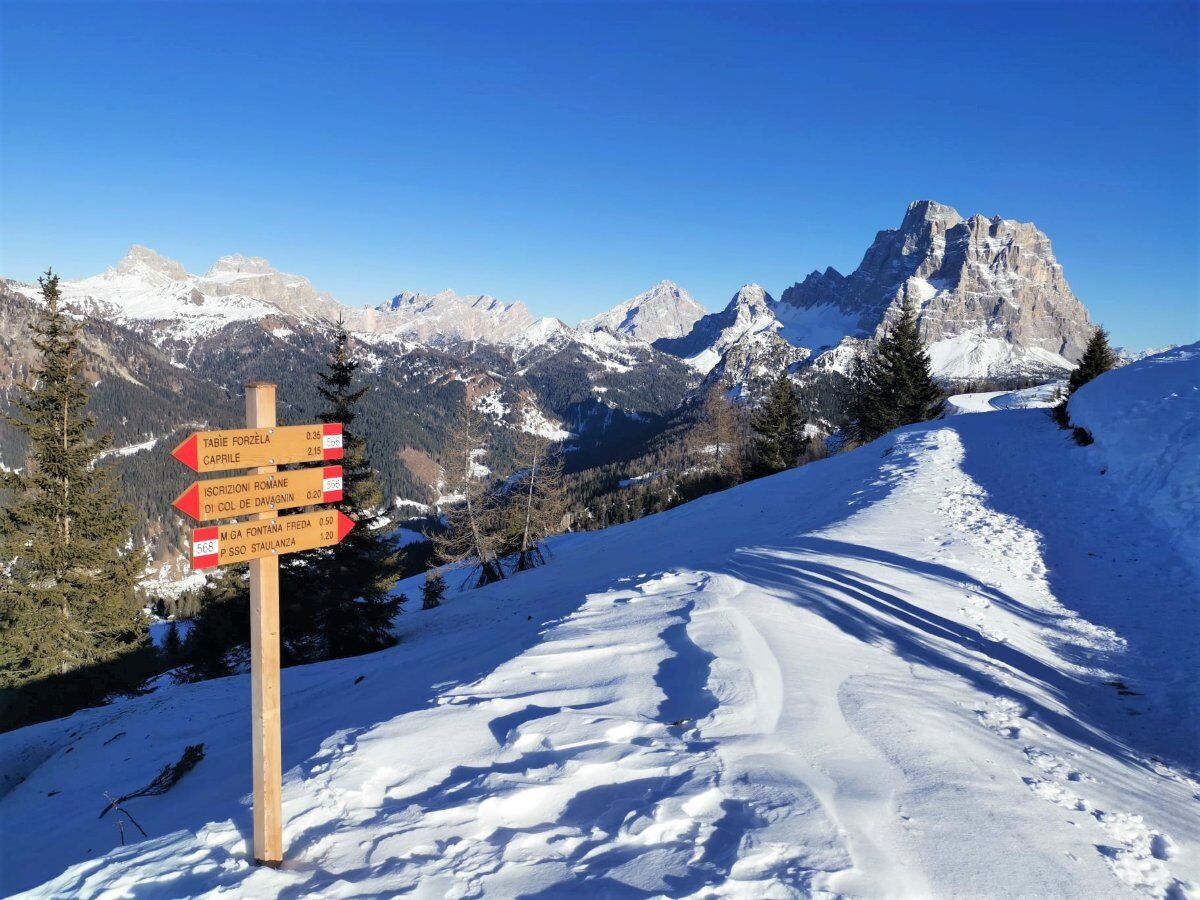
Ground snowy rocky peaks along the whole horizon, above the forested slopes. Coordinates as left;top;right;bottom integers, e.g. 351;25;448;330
4;200;1091;386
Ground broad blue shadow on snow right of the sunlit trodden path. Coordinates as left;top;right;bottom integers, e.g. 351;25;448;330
959;410;1200;768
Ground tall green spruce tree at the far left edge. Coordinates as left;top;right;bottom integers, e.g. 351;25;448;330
0;272;154;721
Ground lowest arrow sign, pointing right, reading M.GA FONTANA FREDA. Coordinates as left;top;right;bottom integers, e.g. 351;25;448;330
192;510;354;570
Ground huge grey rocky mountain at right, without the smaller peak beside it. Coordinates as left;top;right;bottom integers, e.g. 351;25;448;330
780;200;1091;378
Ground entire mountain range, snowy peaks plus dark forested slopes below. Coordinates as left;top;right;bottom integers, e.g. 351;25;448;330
0;202;1113;556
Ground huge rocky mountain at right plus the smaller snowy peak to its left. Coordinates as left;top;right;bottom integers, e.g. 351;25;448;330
655;200;1092;380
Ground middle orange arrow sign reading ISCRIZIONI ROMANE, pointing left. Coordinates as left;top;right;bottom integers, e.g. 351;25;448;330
174;466;342;522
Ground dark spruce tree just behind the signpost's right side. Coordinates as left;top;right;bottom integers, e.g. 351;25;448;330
281;322;403;661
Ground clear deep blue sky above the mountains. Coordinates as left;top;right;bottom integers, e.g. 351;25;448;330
0;0;1200;347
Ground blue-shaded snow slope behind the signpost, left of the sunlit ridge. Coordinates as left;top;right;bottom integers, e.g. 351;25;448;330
0;580;597;896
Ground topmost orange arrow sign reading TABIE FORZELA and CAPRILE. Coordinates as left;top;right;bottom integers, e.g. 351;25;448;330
170;424;342;472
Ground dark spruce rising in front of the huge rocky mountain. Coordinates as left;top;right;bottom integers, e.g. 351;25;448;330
848;298;942;444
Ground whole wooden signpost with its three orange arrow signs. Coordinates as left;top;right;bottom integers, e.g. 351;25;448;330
172;382;354;866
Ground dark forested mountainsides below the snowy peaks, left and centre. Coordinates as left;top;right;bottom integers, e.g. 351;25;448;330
0;284;697;559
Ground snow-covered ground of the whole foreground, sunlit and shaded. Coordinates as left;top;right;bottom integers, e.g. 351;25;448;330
0;348;1200;898
